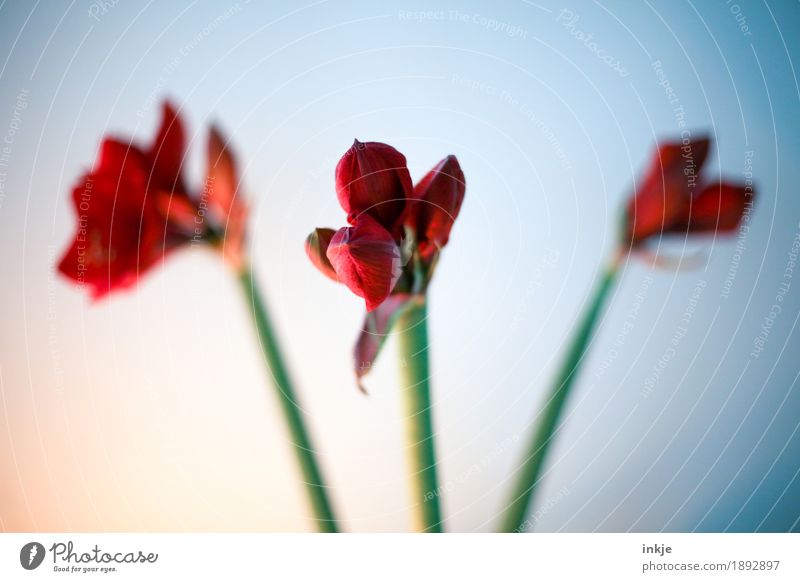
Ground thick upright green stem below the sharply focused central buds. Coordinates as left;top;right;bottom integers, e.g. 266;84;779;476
395;299;442;533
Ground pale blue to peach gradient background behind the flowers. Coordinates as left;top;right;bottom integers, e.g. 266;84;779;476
0;0;800;531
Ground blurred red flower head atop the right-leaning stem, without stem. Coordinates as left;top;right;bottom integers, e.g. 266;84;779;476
624;138;754;247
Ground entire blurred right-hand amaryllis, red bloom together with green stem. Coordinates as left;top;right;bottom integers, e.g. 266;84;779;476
501;134;754;532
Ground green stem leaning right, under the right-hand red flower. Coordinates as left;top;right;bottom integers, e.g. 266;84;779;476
501;260;619;532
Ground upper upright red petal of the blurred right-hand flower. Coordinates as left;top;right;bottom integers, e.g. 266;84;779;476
627;137;711;244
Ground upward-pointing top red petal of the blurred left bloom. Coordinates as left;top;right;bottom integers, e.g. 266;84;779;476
149;101;186;190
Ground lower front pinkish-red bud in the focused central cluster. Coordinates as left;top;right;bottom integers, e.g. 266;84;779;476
327;214;402;311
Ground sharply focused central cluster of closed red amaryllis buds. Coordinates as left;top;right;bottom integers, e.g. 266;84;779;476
306;140;465;388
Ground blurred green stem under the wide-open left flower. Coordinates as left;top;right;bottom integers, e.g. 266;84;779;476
239;268;337;532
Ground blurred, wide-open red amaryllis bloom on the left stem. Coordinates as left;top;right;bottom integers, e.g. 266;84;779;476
58;103;246;299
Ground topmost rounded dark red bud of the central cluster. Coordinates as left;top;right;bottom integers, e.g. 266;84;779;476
336;140;413;239
